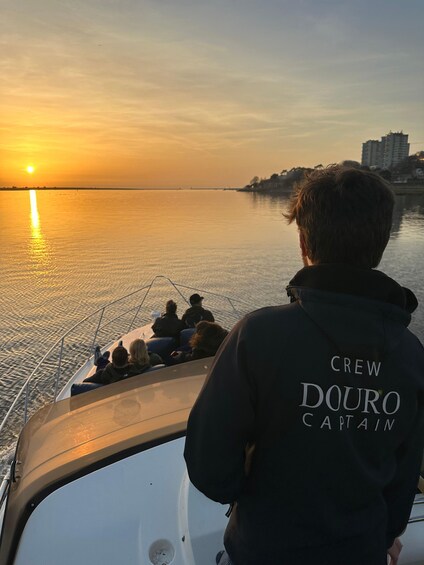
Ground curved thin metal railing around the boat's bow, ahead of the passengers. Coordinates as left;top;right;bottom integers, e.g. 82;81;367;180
0;275;251;476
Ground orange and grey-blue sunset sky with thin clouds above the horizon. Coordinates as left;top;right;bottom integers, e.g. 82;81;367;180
0;0;424;187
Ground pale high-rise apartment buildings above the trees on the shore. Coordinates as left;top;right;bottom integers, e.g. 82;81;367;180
361;131;409;169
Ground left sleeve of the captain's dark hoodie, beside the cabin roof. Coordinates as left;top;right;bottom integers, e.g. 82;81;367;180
184;322;255;504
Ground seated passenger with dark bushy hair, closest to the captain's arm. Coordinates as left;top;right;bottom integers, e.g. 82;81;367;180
172;321;228;363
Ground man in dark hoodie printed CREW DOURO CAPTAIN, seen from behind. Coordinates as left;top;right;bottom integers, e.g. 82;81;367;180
185;167;424;565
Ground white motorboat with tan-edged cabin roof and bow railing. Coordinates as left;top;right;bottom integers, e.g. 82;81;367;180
0;276;424;565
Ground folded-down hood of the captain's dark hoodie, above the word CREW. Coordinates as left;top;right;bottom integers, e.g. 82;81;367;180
287;264;418;359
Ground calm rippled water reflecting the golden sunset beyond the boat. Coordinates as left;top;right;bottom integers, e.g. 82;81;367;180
0;190;424;412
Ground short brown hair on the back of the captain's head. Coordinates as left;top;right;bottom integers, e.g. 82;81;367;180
285;165;394;268
